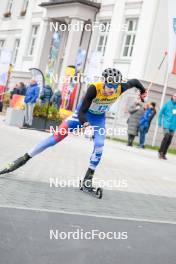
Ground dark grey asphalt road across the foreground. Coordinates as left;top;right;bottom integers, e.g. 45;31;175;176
0;208;176;264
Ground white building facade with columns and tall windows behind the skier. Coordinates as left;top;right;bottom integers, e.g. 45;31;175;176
0;0;176;146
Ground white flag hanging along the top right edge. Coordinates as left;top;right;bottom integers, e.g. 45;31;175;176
168;0;176;74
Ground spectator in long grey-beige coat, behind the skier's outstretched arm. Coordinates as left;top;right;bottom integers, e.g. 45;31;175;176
127;101;144;147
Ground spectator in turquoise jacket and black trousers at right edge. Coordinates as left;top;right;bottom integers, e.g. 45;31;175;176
158;93;176;160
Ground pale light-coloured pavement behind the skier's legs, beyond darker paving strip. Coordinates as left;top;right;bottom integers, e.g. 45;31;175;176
0;114;176;197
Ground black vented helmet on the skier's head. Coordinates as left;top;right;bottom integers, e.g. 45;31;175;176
102;68;122;83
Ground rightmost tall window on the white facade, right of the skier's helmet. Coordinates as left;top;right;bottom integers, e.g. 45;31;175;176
122;18;138;58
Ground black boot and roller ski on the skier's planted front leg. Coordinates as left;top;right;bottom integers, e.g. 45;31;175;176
79;169;103;199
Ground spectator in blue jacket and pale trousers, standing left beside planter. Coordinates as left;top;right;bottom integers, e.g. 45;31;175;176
24;79;39;127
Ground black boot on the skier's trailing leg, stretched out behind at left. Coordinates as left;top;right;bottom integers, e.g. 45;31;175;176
0;153;31;175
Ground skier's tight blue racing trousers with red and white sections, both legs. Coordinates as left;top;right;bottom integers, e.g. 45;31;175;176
28;112;106;170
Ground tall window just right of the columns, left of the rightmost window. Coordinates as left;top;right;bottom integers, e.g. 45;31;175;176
96;21;110;56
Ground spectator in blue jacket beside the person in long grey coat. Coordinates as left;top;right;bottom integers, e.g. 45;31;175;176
139;103;156;148
